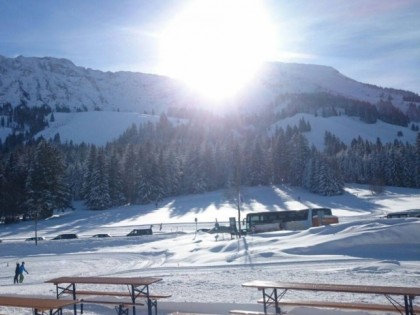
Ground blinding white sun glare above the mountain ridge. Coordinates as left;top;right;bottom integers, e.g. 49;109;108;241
159;0;275;100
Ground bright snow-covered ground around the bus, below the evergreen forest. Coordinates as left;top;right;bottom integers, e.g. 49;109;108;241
0;185;420;315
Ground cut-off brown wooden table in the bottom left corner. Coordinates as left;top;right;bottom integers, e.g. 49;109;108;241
0;295;78;315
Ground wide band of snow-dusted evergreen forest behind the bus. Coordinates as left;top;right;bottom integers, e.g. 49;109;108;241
0;115;420;222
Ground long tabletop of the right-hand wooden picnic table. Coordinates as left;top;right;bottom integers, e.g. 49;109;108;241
242;280;420;296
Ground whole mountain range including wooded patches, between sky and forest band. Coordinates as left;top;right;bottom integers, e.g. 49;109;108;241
0;56;420;147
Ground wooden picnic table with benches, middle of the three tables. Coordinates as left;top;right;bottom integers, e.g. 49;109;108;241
46;277;162;315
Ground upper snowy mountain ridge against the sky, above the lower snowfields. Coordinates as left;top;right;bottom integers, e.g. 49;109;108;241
0;56;412;112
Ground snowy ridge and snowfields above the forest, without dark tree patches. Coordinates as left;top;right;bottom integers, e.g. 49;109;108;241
0;56;415;148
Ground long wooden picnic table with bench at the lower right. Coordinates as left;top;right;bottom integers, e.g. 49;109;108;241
242;280;420;315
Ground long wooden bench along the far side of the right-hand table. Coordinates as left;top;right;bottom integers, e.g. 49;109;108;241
258;300;420;314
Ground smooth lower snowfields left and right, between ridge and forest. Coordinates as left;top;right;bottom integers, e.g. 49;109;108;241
23;111;417;149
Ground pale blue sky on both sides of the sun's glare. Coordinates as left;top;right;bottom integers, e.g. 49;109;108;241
0;0;420;93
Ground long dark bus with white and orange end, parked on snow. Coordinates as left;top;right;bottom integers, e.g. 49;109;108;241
245;208;338;233
